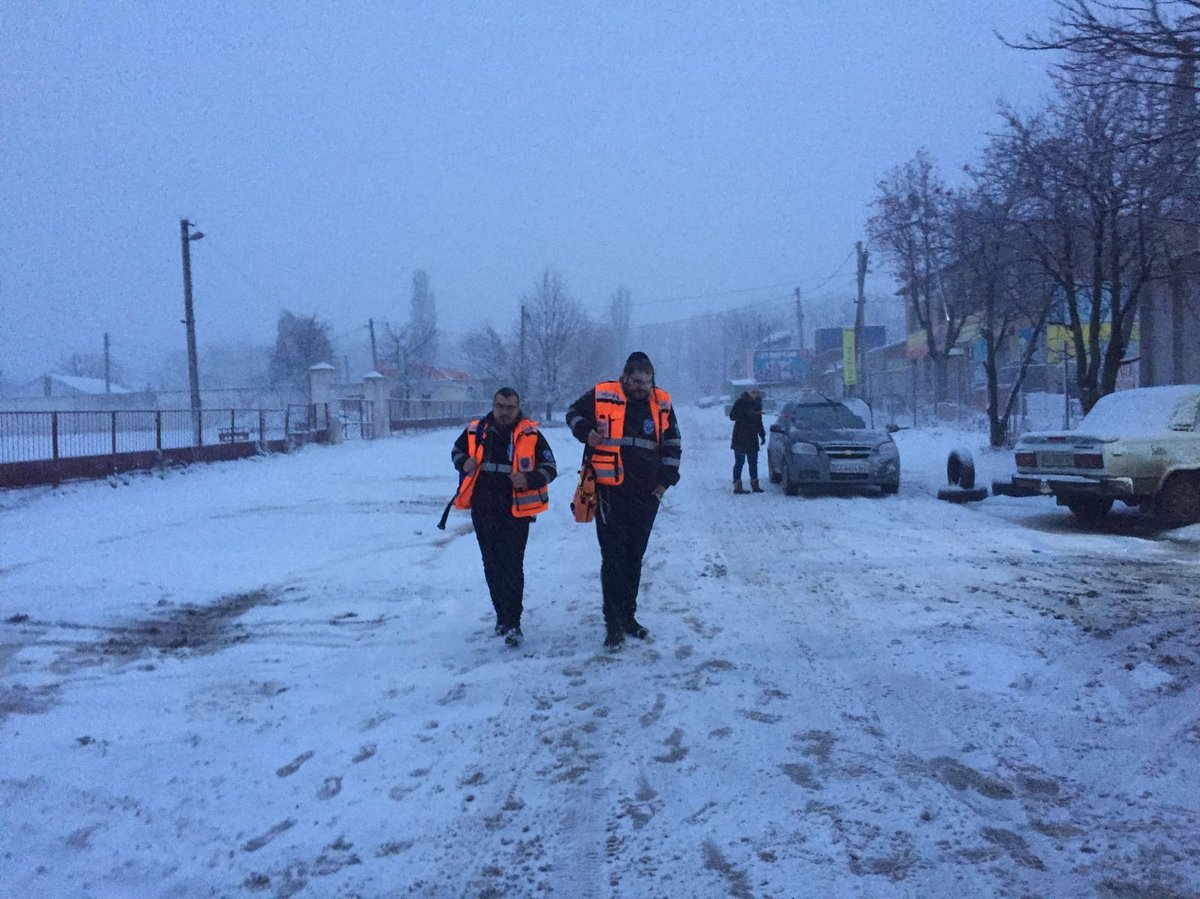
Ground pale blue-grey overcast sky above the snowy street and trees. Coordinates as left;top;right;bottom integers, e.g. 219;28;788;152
0;0;1052;379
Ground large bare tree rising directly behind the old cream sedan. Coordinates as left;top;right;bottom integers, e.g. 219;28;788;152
1000;70;1183;410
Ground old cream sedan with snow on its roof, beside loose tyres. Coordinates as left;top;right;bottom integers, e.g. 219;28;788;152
992;384;1200;526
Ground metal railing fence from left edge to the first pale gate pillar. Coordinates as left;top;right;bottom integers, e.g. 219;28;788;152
0;406;328;463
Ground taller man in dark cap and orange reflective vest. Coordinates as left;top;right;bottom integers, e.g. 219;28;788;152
566;353;683;649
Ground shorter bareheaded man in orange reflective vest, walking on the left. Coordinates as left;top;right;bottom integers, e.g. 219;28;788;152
450;388;558;646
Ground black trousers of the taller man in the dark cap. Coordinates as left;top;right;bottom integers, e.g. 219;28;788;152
595;487;659;631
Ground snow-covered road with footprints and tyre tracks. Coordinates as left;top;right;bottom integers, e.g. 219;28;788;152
0;408;1200;898
